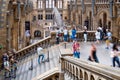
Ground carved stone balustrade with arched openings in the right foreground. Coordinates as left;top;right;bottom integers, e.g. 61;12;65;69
61;57;120;80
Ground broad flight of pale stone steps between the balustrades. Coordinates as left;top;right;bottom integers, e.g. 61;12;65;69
15;46;59;80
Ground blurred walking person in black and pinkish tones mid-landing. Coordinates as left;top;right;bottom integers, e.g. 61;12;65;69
88;43;99;63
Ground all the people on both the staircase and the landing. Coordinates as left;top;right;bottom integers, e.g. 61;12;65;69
2;27;120;78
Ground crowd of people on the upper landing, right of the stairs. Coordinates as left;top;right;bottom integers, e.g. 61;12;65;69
56;27;120;67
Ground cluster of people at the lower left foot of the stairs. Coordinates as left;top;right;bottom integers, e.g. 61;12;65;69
2;49;18;78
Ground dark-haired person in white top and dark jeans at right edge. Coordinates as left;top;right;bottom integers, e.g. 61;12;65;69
111;44;120;67
